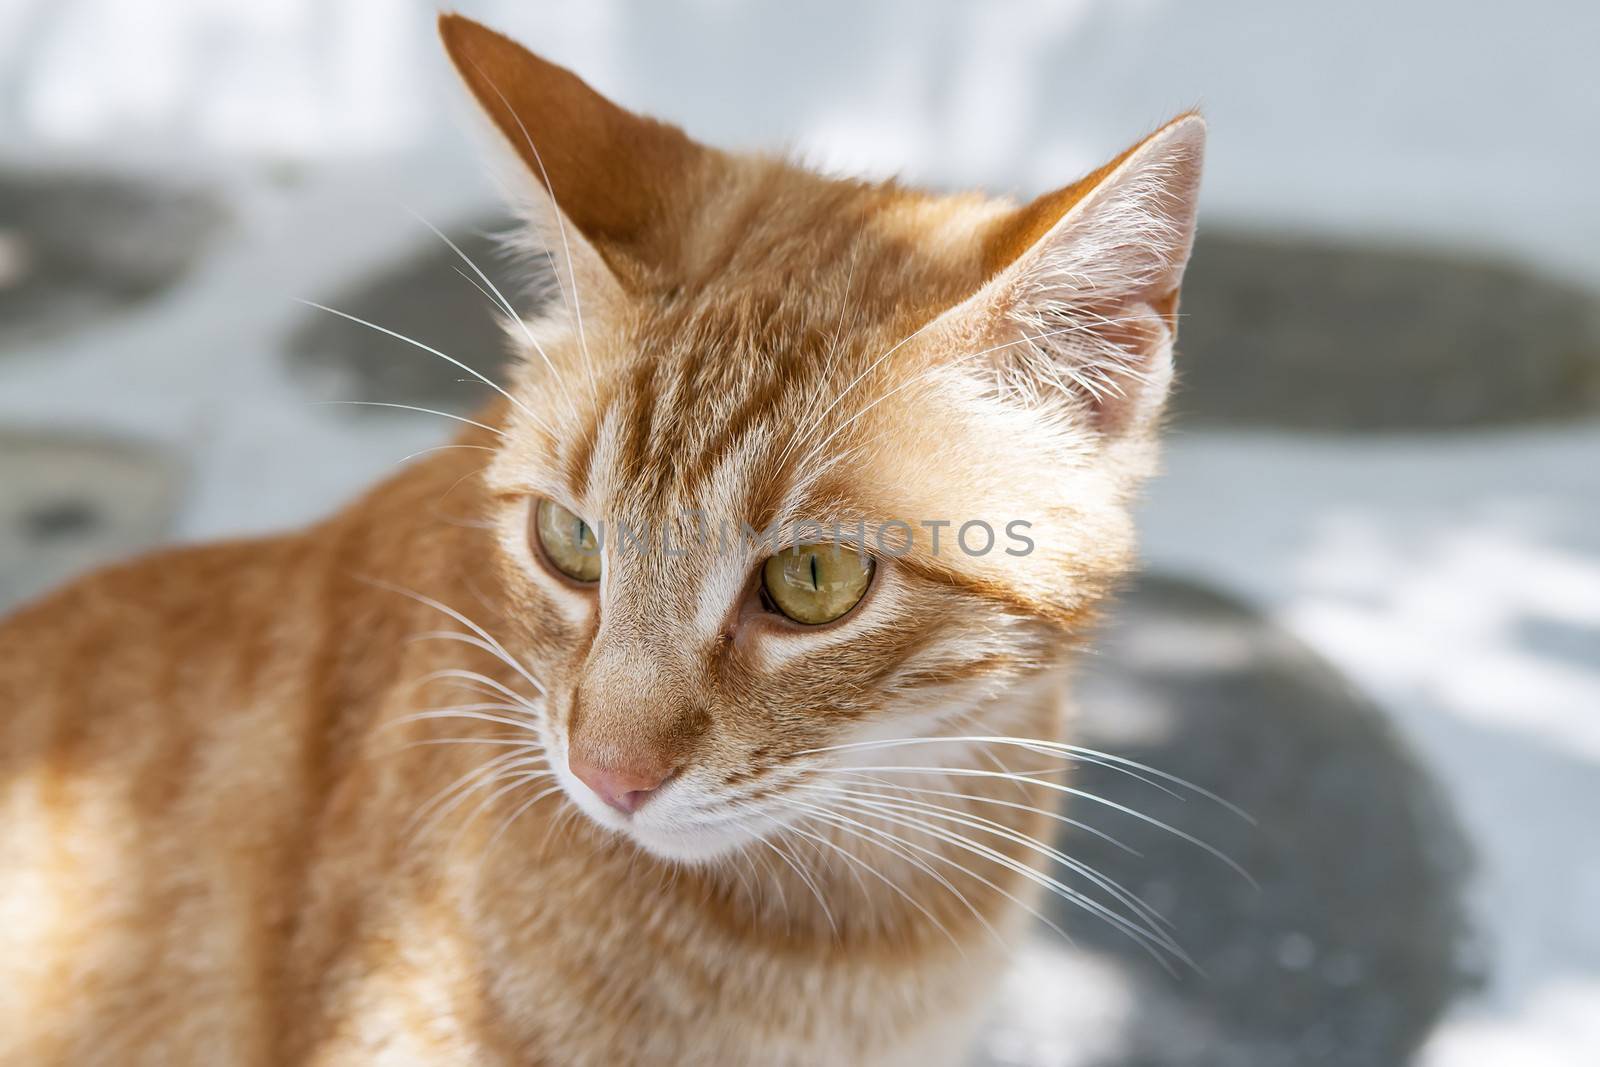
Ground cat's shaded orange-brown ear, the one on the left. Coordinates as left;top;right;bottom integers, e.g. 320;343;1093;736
438;14;717;293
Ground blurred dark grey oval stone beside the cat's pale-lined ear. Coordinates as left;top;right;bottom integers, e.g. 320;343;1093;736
1173;235;1600;430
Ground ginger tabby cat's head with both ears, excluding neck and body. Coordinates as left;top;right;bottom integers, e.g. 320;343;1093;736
440;16;1205;859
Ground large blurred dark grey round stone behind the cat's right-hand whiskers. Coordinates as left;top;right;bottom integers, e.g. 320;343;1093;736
972;577;1478;1067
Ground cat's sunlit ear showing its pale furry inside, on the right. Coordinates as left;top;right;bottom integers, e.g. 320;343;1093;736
934;114;1205;435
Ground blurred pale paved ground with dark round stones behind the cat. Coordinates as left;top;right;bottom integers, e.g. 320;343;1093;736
0;0;1600;1067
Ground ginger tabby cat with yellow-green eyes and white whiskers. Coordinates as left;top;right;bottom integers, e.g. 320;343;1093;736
0;16;1203;1067
